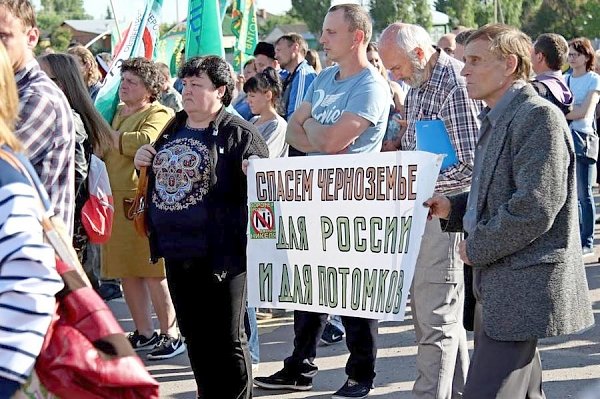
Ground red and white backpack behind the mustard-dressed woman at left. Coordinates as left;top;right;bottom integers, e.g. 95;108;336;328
81;154;115;244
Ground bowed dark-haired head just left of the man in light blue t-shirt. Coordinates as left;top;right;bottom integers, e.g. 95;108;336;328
244;67;282;115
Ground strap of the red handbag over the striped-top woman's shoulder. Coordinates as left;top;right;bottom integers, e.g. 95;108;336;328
0;148;92;287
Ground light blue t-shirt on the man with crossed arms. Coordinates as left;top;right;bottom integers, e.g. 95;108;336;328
304;65;391;154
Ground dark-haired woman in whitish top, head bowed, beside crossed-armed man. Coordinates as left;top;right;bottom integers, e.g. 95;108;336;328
244;67;289;158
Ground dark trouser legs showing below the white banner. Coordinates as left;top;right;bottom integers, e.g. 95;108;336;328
284;310;378;383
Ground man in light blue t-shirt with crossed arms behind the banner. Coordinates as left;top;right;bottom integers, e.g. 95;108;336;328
254;4;391;399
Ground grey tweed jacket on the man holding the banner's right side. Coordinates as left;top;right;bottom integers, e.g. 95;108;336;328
442;85;594;341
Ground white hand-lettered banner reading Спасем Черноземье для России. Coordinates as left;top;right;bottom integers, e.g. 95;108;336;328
248;151;443;320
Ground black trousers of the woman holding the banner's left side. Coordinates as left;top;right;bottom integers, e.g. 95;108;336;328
165;258;252;399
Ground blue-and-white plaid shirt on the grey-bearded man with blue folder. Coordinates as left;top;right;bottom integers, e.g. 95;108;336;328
402;51;483;193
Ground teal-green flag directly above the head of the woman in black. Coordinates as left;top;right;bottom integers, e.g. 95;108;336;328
185;0;225;59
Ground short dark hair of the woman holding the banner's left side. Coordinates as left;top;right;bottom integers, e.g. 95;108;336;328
177;55;234;107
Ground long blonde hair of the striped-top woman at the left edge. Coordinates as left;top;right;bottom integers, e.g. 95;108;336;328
0;42;22;151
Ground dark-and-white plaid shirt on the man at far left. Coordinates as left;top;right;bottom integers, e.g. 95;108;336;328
15;60;75;235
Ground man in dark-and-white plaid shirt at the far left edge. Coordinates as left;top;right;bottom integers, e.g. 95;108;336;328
0;0;75;235
